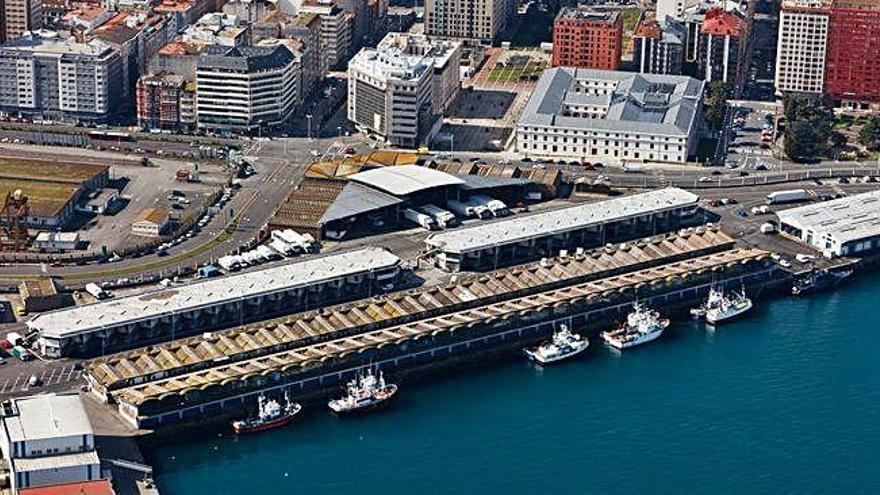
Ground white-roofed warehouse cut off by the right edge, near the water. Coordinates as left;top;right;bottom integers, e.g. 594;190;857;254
777;191;880;258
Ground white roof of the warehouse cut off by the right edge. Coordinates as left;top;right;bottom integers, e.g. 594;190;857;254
777;191;880;244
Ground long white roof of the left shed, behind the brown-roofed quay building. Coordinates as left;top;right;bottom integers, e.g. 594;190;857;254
28;247;400;338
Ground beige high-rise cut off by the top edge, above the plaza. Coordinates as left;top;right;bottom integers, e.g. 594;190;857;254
425;0;516;43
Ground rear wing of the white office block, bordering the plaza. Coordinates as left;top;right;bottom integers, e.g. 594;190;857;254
376;32;461;114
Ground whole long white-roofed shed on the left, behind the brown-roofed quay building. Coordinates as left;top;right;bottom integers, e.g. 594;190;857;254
27;248;401;357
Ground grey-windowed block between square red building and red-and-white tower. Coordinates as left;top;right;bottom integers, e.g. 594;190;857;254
633;14;687;74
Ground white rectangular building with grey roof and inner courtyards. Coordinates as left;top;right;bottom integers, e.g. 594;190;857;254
516;67;705;163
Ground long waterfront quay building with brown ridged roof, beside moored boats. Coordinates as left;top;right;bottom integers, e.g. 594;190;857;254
85;227;779;428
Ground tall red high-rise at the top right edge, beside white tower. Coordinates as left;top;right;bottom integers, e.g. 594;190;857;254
825;0;880;104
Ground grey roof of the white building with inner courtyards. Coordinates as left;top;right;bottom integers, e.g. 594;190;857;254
517;67;705;137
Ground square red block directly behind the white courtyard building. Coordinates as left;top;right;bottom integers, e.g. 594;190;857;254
552;7;623;70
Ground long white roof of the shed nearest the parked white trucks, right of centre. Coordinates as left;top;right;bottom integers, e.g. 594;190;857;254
425;187;699;253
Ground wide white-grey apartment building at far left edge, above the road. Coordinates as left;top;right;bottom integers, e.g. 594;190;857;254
0;31;125;122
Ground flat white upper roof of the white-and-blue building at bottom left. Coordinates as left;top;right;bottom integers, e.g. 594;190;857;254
3;394;94;442
